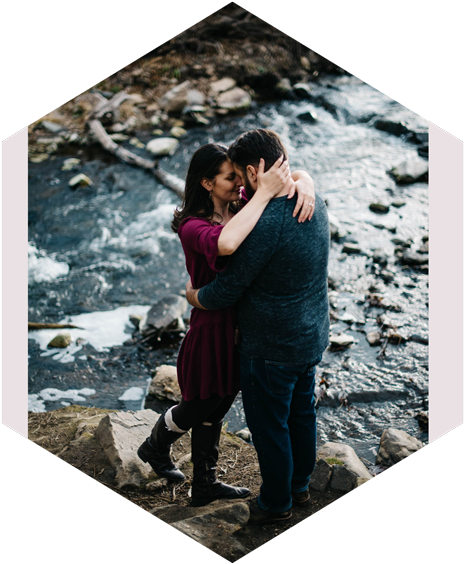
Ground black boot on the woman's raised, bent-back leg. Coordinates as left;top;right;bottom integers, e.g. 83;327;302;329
137;412;186;482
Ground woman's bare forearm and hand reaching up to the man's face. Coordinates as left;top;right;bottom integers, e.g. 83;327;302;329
218;156;290;256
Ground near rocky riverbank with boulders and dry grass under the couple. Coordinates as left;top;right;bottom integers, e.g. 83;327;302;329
28;400;423;562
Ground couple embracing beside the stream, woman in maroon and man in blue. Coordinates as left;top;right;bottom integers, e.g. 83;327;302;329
138;129;330;524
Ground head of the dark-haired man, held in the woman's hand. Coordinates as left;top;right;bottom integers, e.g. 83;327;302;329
227;129;288;198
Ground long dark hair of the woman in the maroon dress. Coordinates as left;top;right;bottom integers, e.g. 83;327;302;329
171;143;241;233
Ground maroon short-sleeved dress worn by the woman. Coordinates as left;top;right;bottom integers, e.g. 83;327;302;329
177;212;245;401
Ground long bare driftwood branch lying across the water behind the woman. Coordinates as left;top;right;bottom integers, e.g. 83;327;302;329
87;91;184;197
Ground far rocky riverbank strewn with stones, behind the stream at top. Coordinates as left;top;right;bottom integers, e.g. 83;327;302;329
29;3;343;166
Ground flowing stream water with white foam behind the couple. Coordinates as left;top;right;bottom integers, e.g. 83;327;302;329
29;76;428;464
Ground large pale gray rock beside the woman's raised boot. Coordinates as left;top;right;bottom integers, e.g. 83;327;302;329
95;409;159;488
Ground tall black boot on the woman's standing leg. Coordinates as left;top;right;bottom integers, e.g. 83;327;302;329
192;421;250;507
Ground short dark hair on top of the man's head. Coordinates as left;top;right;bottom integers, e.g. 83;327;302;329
227;129;288;171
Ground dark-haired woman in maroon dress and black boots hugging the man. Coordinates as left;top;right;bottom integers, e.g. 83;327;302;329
138;143;314;506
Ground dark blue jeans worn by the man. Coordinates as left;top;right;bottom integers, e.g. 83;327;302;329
240;354;322;512
